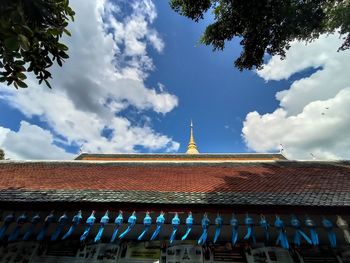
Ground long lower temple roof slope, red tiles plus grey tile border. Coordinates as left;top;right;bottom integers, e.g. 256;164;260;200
0;160;350;211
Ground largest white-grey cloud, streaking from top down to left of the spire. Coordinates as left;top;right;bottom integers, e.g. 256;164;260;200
0;0;179;161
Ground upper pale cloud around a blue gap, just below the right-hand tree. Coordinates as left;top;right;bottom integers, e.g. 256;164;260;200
258;35;350;114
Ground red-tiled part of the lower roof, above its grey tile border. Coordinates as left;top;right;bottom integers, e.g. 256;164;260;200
0;161;350;208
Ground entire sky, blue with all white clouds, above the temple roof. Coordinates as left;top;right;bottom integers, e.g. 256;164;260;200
0;0;350;160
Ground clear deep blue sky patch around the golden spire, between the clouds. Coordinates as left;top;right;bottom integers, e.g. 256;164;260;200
146;1;296;152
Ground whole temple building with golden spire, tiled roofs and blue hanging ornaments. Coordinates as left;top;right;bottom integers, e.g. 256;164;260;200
0;122;350;263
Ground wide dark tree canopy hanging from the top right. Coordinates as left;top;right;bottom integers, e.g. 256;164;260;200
170;0;350;70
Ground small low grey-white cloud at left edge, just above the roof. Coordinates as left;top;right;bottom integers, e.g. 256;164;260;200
0;121;74;160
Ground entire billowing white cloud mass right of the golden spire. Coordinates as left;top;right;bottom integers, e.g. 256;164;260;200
242;35;350;159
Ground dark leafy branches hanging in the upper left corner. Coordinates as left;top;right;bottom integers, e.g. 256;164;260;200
0;0;74;88
